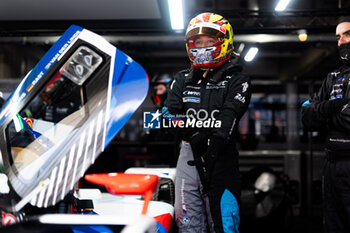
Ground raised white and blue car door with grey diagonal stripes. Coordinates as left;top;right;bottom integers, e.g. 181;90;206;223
0;26;148;207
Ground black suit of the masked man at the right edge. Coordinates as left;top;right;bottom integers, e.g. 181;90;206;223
302;66;350;232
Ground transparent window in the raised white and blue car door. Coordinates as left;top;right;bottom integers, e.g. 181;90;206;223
7;71;85;180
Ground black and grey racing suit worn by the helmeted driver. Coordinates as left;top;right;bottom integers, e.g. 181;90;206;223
163;58;251;233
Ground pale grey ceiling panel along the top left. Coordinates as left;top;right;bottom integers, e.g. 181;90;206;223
0;0;161;21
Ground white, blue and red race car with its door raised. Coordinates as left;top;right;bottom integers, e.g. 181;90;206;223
0;25;174;232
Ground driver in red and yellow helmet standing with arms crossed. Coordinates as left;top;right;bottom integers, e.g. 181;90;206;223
162;13;251;233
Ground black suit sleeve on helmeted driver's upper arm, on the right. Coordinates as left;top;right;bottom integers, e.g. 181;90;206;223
211;74;252;142
